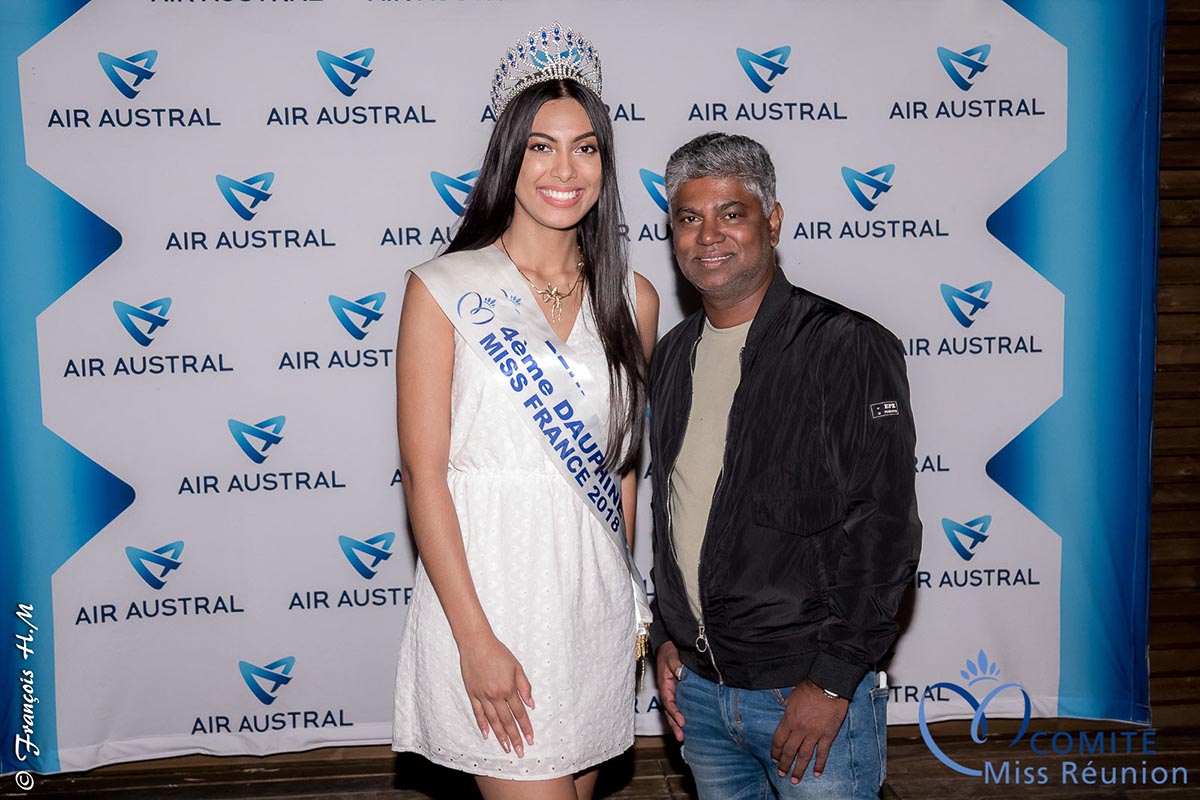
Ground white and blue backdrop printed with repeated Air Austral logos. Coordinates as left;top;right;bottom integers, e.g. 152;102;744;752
0;0;1162;771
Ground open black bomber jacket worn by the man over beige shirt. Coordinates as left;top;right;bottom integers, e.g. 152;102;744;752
650;269;920;697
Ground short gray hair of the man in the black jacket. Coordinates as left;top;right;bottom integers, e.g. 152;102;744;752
664;131;775;216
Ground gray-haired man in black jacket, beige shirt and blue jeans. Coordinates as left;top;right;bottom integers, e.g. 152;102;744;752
650;133;920;800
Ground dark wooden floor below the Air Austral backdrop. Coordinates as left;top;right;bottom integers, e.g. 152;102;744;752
7;720;1200;800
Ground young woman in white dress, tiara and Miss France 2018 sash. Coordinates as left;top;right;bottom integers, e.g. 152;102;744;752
392;24;658;800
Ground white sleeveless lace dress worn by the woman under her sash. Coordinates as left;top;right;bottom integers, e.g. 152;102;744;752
392;254;636;780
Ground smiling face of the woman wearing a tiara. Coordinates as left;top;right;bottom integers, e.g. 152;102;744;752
512;98;601;230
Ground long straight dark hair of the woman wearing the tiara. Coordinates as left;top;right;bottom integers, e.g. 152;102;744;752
445;79;646;475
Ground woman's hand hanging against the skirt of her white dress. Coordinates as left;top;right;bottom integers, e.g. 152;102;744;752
458;636;533;758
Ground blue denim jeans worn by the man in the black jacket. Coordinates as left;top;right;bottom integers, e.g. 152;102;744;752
676;667;888;800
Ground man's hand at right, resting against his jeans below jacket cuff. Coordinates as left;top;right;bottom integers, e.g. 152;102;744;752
770;680;850;783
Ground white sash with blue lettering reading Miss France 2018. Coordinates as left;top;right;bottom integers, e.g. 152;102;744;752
413;247;652;630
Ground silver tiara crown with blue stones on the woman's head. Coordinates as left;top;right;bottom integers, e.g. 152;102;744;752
492;22;602;119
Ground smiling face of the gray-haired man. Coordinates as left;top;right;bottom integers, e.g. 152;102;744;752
671;176;784;306
